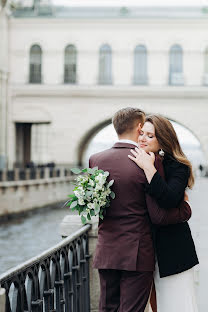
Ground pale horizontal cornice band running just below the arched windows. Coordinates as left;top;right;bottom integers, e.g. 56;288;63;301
11;85;208;99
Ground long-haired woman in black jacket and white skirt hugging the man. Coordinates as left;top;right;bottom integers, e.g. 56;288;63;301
129;115;199;312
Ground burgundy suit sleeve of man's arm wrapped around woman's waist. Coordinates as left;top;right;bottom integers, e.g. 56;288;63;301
146;159;192;225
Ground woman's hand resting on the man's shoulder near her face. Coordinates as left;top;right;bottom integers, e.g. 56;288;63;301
128;147;155;170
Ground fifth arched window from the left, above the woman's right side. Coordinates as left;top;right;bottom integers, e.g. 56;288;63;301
169;44;184;85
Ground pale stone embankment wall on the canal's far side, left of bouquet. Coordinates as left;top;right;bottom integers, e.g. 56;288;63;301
0;172;73;219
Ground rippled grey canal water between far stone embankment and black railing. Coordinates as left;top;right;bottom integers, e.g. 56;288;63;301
0;204;77;274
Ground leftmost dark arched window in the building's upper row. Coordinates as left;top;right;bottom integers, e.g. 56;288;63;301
29;44;42;83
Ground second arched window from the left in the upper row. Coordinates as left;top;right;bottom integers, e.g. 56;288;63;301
64;44;77;83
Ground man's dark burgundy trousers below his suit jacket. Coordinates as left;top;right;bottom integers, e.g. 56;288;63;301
99;269;153;312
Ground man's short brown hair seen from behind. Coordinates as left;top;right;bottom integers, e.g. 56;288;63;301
112;107;145;135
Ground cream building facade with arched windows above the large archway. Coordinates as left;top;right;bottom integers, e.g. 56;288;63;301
0;1;208;167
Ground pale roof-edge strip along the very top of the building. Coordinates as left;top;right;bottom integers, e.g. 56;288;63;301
13;3;208;20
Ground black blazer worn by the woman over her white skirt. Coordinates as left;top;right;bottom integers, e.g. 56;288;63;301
147;154;199;277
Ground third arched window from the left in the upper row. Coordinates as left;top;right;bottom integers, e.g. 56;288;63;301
99;44;112;85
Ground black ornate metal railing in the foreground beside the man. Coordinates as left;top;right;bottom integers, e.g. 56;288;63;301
0;224;91;312
